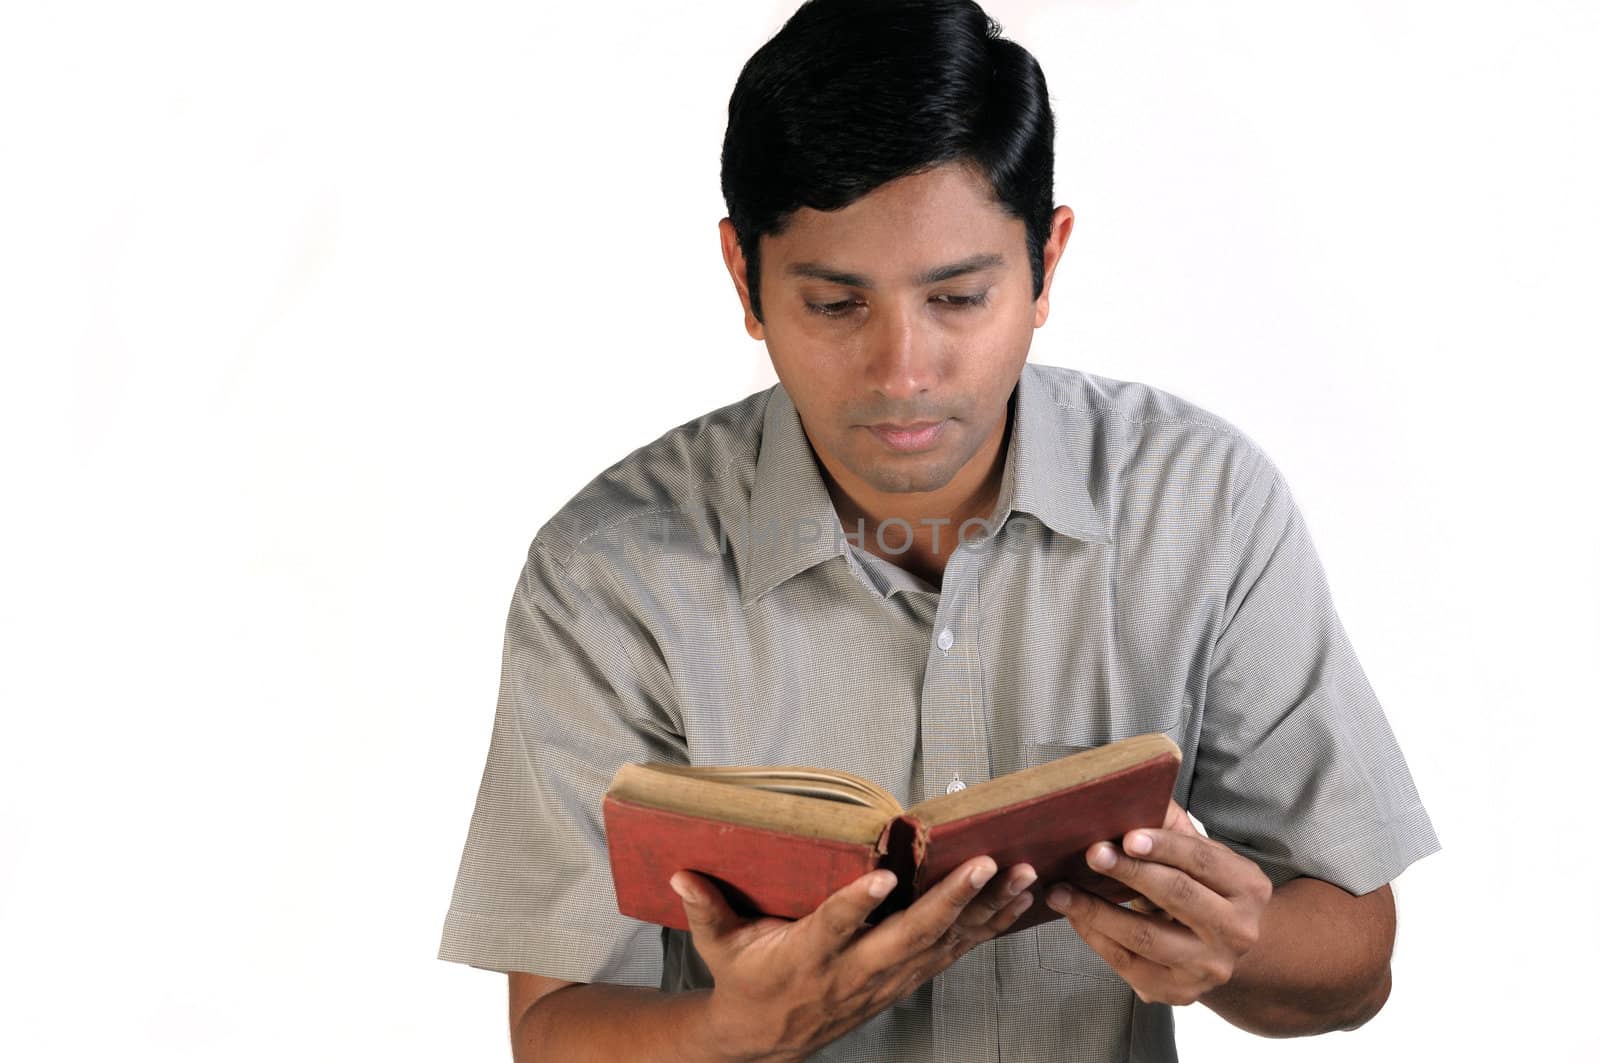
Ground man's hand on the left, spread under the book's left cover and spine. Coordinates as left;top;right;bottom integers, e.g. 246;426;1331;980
672;856;1037;1061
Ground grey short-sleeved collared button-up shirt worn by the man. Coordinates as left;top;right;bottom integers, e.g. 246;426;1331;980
438;363;1438;1063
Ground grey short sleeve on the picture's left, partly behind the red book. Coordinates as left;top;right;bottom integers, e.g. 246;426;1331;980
438;541;685;986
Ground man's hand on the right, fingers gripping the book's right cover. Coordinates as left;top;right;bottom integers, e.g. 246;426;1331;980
1046;800;1272;1005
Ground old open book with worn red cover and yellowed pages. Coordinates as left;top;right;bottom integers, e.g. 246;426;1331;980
602;733;1182;933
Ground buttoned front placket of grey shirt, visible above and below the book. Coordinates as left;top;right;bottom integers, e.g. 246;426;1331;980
920;549;1000;1063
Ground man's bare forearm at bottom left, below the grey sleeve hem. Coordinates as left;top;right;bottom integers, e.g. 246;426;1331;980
512;983;747;1063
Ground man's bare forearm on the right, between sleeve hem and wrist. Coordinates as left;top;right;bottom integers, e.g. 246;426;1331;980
1200;879;1394;1037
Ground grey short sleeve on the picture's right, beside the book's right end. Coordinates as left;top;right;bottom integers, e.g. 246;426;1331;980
1189;456;1440;895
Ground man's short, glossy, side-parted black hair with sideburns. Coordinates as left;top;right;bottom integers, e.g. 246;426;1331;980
722;0;1056;320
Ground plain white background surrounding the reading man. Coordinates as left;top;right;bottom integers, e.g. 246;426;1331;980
0;0;1600;1061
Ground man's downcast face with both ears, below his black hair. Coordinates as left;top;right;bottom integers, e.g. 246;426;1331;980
722;163;1072;509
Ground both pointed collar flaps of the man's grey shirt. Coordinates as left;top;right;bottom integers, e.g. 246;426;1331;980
739;363;1110;605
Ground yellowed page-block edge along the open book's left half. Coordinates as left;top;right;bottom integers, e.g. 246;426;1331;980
606;764;896;845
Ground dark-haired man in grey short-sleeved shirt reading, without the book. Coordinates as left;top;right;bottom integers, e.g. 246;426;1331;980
440;0;1438;1060
